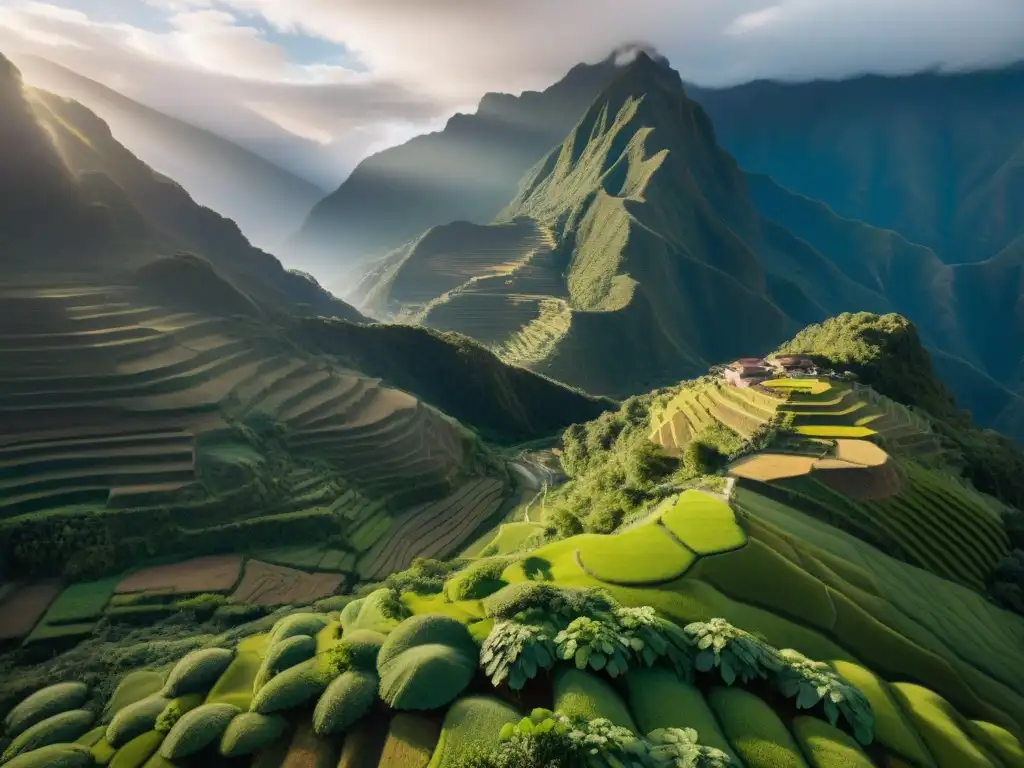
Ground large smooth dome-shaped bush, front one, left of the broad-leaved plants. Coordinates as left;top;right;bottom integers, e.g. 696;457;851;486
378;644;476;710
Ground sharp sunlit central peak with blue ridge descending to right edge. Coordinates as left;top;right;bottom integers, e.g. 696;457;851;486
342;55;1024;442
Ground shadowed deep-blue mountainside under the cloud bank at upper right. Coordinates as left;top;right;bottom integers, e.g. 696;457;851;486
689;67;1024;263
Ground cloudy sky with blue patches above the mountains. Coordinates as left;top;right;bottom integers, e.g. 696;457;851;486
0;0;1024;188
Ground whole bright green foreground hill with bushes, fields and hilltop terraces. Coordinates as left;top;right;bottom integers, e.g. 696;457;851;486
0;318;1024;768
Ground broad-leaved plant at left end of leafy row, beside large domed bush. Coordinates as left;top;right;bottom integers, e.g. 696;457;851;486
480;621;556;690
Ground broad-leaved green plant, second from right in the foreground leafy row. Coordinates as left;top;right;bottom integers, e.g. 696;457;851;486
683;618;778;685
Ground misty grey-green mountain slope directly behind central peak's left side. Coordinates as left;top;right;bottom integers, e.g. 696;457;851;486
290;57;616;270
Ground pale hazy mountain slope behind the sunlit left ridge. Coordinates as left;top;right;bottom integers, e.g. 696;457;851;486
16;56;324;256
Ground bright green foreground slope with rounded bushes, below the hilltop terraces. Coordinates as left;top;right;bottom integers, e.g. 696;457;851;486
7;492;1024;768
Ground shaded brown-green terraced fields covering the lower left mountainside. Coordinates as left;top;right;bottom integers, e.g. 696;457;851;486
0;285;507;606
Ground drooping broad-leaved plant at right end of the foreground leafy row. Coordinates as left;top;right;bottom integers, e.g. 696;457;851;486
774;648;874;744
